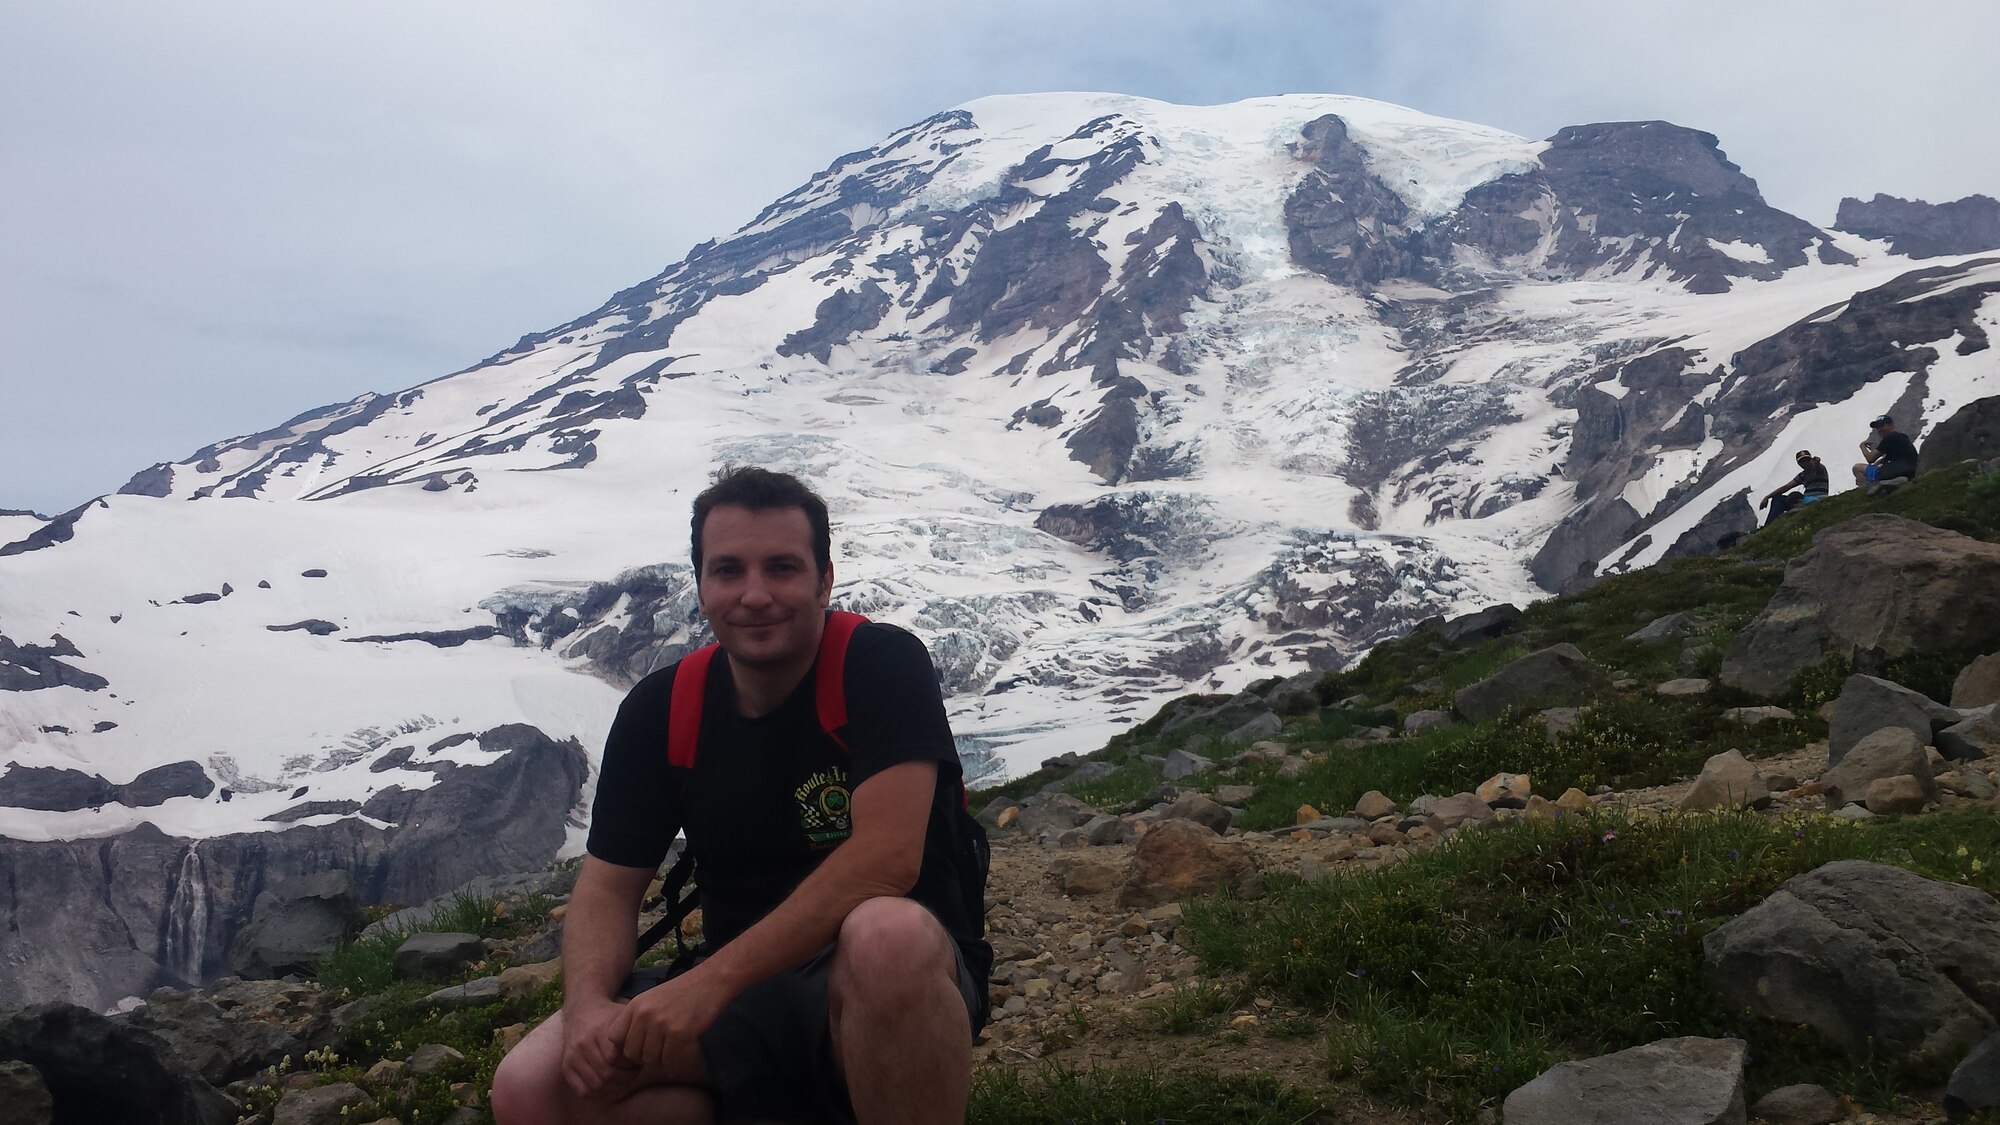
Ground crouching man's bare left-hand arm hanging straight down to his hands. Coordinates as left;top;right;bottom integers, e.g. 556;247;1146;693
562;855;652;1097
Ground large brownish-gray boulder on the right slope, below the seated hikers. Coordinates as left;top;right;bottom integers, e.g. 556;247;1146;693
1722;512;2000;697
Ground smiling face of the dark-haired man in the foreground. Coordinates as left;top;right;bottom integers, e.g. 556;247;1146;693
700;504;834;669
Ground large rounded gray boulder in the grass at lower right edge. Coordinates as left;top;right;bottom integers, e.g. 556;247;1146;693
1702;859;2000;1059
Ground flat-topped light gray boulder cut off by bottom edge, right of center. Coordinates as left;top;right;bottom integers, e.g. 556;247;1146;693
1500;1035;1748;1125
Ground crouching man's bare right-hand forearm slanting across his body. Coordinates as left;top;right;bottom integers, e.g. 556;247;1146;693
608;761;938;1065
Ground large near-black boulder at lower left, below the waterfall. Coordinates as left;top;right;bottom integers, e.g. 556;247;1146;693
0;1005;236;1125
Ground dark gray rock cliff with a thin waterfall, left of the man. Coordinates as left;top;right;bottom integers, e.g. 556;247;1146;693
0;727;586;1007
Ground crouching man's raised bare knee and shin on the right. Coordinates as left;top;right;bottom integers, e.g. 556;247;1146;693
826;899;972;1125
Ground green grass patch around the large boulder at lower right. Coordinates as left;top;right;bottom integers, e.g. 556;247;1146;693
1182;811;2000;1119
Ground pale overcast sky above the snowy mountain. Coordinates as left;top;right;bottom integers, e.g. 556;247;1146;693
0;0;2000;514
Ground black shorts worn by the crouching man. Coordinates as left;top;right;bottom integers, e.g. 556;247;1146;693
618;941;984;1125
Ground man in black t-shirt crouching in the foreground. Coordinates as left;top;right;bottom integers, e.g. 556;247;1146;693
492;468;992;1125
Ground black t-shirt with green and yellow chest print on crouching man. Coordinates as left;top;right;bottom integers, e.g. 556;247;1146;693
586;623;992;993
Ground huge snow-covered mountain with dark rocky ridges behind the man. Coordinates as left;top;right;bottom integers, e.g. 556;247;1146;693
0;94;2000;996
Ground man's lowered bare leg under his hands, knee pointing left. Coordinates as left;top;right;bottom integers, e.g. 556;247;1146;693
492;1011;714;1125
